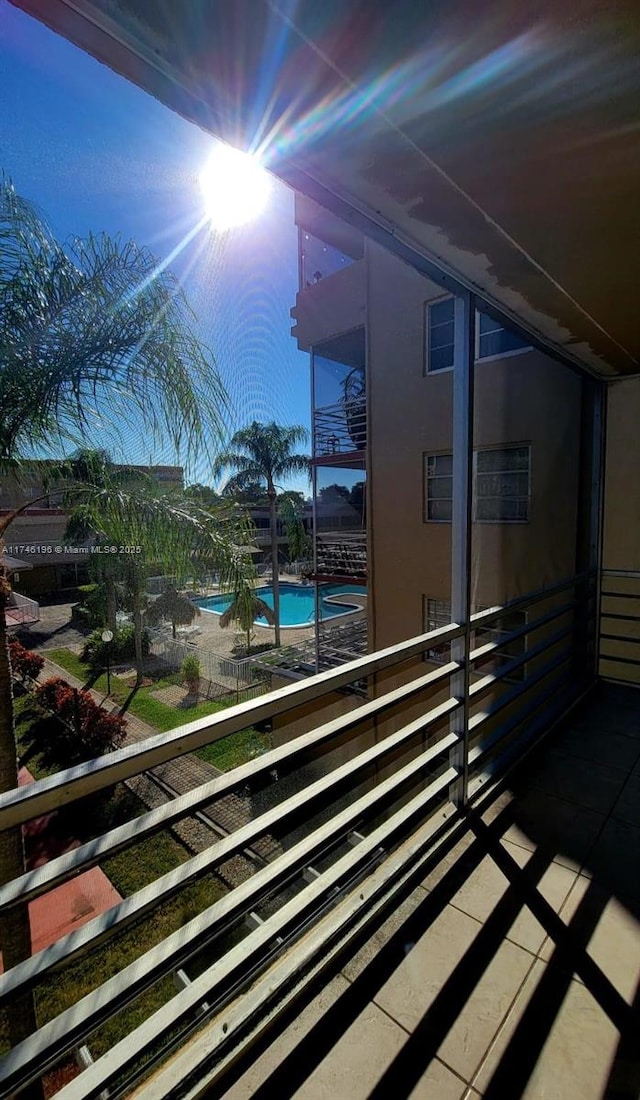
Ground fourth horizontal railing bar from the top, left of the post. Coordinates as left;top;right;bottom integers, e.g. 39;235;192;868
0;748;456;1095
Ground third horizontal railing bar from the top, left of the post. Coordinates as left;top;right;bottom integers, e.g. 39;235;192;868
0;699;457;1004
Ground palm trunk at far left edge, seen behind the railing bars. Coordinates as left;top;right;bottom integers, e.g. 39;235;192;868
0;563;43;1100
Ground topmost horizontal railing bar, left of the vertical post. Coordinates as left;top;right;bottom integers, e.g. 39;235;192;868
0;623;463;831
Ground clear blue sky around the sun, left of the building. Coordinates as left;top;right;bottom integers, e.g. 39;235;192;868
0;0;309;491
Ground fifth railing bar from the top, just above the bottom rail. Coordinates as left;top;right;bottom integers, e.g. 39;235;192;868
37;768;456;1100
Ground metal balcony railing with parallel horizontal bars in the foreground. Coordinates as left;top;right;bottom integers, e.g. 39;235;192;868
0;574;595;1100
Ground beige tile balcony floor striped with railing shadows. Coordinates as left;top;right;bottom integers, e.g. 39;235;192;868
217;685;640;1100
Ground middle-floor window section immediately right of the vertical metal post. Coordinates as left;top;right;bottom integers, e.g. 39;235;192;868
474;447;530;524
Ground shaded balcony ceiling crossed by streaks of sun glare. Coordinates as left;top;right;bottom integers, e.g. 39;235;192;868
13;0;640;375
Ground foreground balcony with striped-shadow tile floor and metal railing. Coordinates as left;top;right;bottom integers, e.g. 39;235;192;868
0;576;640;1100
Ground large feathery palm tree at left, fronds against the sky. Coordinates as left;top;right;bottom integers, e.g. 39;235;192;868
0;177;235;1060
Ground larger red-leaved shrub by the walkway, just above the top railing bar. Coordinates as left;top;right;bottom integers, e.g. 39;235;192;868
35;677;126;765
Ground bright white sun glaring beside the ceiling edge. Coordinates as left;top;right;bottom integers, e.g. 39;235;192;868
199;145;272;230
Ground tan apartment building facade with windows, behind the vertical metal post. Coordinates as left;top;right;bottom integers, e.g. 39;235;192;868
291;197;593;690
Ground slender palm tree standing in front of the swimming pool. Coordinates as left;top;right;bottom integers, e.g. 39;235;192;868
213;420;310;646
